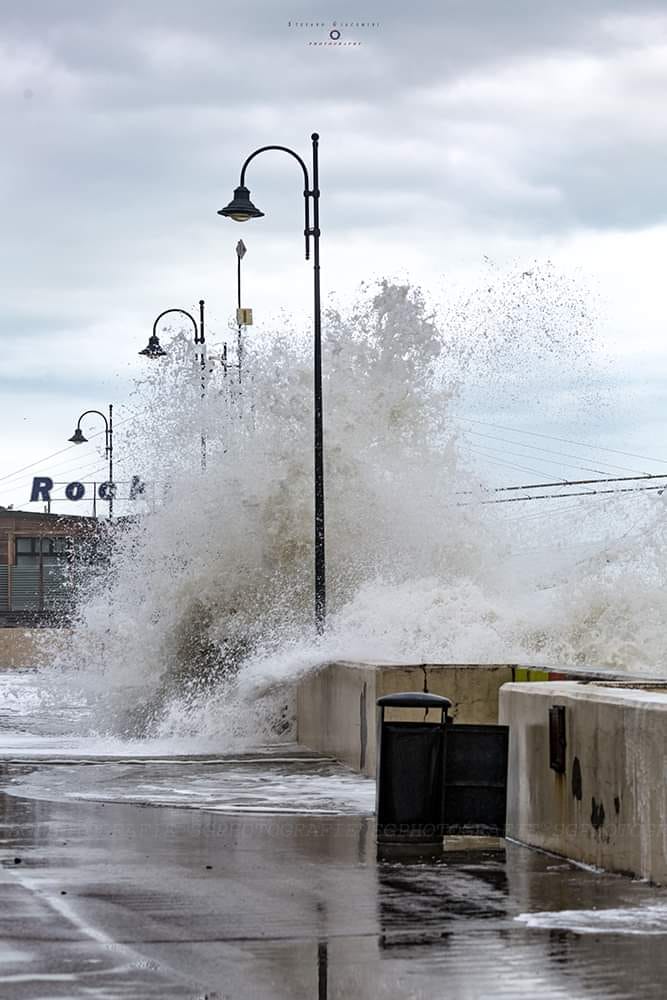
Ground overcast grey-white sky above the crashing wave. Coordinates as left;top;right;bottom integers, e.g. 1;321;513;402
0;0;667;512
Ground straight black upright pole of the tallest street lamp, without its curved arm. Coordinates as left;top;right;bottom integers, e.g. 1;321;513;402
311;132;327;633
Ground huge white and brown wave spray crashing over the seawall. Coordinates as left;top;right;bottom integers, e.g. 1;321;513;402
37;265;667;740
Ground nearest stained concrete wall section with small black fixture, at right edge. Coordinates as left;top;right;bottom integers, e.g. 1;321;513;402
499;678;667;884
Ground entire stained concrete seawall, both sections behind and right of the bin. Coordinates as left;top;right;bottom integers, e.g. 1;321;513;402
297;662;667;884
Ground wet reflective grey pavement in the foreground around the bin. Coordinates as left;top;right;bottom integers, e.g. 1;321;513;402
0;750;667;1000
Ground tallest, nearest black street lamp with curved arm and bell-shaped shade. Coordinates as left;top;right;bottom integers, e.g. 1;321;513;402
218;132;326;633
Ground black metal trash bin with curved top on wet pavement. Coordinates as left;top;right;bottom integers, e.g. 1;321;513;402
376;691;452;848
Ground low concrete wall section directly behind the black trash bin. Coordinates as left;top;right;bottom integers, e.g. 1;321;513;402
297;662;515;776
